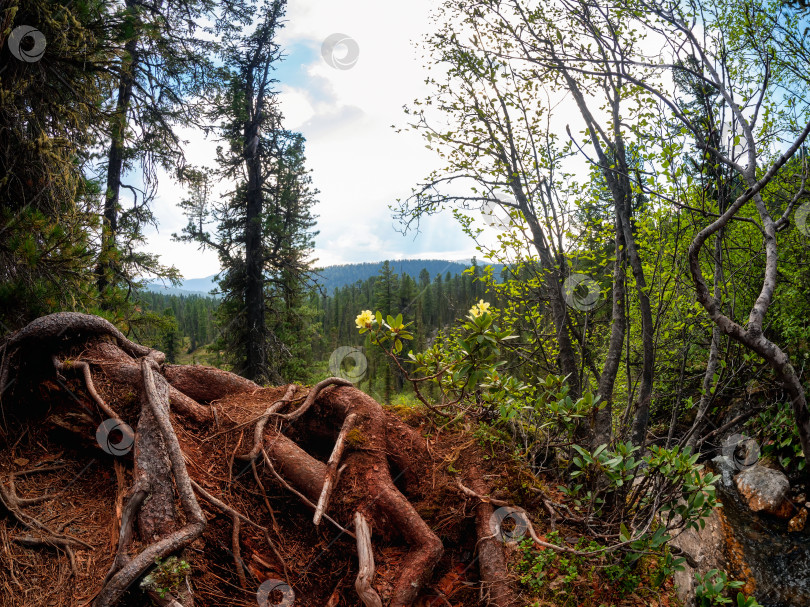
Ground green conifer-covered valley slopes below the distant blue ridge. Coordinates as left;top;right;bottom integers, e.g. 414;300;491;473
134;260;495;390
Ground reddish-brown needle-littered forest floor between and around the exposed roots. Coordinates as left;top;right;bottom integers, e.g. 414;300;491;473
0;316;678;607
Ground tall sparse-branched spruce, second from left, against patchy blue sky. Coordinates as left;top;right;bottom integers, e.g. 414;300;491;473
96;0;215;309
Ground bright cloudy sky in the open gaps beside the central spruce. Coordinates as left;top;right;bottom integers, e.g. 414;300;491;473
140;0;476;278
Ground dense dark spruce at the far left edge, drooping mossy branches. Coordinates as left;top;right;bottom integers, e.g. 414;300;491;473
0;0;110;333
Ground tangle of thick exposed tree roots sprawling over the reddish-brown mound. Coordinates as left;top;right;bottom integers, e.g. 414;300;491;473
0;313;532;607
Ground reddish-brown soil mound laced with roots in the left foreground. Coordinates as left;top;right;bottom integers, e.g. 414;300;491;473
0;313;542;607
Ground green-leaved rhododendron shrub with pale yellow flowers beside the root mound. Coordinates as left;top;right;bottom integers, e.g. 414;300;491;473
355;300;716;572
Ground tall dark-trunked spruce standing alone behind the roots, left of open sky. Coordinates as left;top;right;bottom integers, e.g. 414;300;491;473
178;0;316;383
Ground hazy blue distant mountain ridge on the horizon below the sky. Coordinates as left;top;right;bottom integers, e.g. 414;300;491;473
145;259;503;296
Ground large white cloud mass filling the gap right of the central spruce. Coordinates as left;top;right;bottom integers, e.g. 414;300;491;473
281;0;474;264
